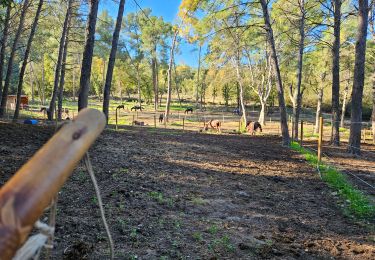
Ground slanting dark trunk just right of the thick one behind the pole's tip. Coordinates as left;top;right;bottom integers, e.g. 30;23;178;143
103;0;125;124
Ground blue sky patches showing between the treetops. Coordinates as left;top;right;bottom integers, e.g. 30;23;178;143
99;0;198;67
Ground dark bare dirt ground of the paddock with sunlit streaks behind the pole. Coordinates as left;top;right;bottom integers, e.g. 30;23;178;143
0;123;375;259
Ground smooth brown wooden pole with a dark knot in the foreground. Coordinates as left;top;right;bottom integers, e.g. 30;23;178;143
0;108;106;260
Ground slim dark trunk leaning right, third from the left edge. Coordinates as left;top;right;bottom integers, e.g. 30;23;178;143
13;0;44;120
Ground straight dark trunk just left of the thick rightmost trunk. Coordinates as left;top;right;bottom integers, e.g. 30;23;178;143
331;0;342;146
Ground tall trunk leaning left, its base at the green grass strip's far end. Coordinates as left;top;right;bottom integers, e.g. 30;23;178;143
260;0;290;146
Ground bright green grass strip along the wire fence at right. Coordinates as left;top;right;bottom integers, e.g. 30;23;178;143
291;142;375;219
